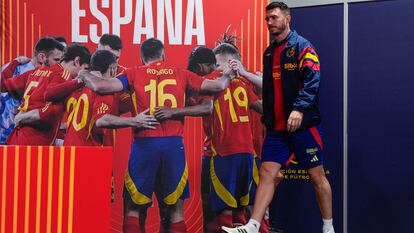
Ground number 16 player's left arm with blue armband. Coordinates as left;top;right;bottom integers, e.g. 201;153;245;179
78;70;123;94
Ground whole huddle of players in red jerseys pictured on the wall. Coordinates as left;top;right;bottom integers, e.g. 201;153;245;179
1;31;262;232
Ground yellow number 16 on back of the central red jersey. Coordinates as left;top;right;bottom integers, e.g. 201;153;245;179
145;79;177;114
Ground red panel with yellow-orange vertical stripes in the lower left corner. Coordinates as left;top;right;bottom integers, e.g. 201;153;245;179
0;146;112;233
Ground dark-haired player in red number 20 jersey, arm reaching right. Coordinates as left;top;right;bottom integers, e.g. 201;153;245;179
64;50;157;146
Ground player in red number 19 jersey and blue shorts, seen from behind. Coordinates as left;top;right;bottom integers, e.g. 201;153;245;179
204;43;262;232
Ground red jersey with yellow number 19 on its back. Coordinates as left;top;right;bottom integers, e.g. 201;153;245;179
212;73;258;156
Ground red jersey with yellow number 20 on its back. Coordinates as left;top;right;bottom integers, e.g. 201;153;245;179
63;87;114;146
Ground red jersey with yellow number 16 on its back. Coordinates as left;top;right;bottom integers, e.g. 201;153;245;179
126;62;204;137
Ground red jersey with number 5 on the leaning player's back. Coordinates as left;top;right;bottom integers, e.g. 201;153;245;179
2;64;72;145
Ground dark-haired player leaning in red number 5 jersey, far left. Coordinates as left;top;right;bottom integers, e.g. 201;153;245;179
1;43;90;145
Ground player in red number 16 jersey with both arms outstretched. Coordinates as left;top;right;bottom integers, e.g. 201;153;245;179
80;38;230;233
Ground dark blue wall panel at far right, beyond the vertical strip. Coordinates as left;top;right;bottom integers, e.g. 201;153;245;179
348;0;414;233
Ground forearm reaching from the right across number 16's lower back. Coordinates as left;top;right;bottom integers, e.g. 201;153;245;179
154;99;213;121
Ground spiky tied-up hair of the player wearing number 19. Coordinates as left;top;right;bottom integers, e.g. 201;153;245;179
213;26;241;60
